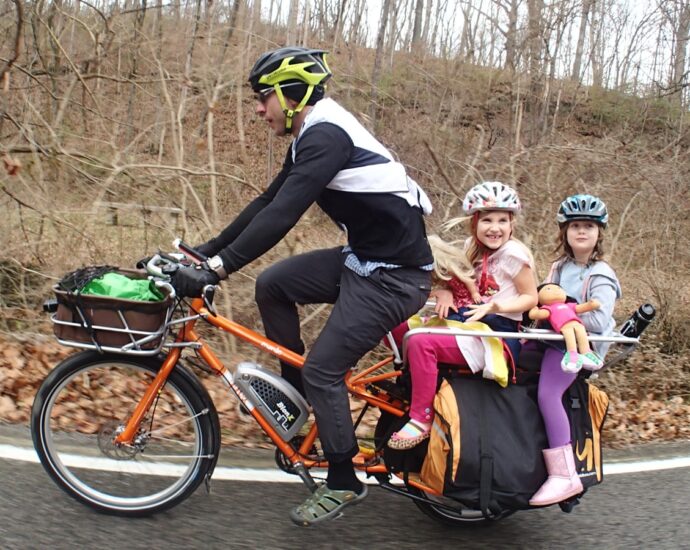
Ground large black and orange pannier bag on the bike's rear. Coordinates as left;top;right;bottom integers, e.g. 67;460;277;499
420;377;608;517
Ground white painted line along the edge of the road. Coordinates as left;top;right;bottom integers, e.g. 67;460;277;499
0;444;690;483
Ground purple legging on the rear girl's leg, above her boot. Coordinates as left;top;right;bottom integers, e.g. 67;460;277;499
539;348;577;449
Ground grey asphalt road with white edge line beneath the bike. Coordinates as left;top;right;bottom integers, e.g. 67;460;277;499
0;459;690;550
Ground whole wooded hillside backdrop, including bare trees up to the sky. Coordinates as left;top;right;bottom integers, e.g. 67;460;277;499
0;0;690;440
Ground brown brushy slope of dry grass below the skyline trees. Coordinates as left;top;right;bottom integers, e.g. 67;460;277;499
0;21;690;446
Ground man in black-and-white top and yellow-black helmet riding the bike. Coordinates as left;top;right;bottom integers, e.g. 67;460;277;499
174;47;433;525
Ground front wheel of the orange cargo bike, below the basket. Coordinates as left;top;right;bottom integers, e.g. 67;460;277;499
31;352;220;516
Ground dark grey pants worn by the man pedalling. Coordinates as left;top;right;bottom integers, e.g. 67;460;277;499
256;247;431;462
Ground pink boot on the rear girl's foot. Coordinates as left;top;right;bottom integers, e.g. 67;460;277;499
529;444;583;506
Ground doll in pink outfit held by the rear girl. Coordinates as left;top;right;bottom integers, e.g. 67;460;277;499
529;283;603;373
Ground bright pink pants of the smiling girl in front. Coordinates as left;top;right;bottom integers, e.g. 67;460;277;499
391;321;467;423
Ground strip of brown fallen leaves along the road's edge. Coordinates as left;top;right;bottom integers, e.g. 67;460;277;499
0;335;690;447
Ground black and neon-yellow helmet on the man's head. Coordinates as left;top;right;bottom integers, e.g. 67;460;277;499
248;46;333;134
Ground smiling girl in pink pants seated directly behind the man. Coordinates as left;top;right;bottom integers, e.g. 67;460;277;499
388;182;537;449
